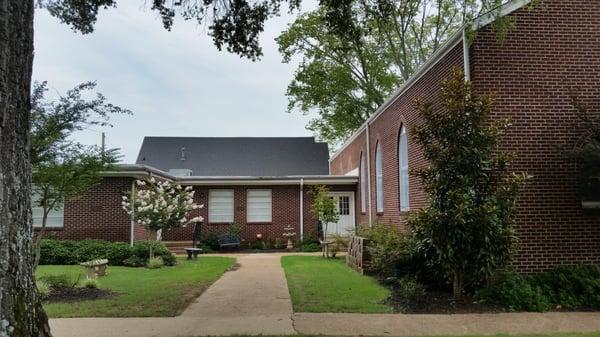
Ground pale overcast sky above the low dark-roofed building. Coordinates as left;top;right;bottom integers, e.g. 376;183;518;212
33;0;311;163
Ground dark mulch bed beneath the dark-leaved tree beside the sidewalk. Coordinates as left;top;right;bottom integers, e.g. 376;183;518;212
388;291;502;314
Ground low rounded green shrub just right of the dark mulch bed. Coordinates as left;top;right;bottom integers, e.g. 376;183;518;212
478;271;551;311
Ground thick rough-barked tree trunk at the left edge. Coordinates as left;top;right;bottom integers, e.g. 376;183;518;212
0;0;51;337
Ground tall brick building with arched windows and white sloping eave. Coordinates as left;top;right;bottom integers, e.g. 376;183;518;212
330;0;600;271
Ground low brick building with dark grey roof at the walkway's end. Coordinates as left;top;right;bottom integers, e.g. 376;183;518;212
33;137;357;242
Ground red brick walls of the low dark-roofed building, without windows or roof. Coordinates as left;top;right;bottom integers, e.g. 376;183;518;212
47;178;356;242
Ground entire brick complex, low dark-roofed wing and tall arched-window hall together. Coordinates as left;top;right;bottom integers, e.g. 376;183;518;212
34;0;600;272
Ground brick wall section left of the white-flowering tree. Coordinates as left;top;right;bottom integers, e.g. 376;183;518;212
40;178;132;241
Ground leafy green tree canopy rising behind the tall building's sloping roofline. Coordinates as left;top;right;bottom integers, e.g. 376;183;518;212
277;0;507;146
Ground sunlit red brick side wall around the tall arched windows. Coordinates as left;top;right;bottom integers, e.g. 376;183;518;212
331;43;463;228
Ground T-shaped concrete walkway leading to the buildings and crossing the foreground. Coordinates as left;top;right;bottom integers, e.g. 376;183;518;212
50;254;600;337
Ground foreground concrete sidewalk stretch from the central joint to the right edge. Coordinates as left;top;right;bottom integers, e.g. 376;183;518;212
294;312;600;336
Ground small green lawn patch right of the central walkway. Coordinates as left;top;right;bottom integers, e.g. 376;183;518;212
281;256;392;313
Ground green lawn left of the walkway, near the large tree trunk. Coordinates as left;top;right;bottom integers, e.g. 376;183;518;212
36;256;235;317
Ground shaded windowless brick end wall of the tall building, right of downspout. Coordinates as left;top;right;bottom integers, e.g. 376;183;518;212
471;0;600;271
